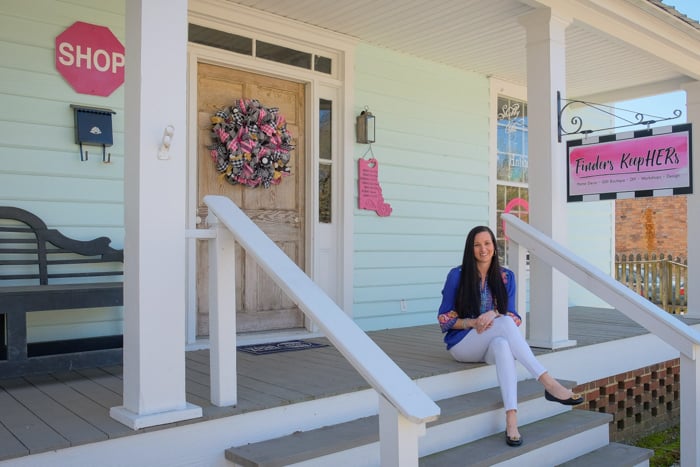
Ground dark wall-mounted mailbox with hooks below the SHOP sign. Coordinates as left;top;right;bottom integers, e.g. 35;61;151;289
71;104;116;163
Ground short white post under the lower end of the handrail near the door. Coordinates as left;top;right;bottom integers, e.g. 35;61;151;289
379;394;425;467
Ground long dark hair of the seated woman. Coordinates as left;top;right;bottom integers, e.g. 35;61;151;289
455;225;508;319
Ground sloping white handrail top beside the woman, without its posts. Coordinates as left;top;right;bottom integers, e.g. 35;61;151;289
502;214;700;360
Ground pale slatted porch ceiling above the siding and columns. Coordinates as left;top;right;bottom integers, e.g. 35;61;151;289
228;0;700;102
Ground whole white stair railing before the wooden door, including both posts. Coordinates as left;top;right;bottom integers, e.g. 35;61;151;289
204;196;440;467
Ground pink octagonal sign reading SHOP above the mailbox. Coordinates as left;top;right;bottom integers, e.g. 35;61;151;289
56;21;124;96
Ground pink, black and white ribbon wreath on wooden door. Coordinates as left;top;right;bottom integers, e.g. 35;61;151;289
208;99;294;188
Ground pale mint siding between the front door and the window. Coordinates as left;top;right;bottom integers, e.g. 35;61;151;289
353;45;489;330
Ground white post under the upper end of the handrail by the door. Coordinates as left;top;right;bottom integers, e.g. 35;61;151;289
208;215;238;407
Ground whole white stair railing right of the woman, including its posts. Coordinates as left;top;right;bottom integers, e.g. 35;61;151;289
502;214;700;465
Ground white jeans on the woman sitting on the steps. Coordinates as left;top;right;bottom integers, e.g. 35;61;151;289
450;316;547;410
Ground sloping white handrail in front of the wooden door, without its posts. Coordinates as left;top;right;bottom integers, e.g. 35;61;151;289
204;195;440;423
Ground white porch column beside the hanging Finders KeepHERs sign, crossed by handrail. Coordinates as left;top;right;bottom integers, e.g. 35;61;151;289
520;8;576;349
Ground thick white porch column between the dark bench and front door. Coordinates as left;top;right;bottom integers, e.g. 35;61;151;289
110;0;202;429
